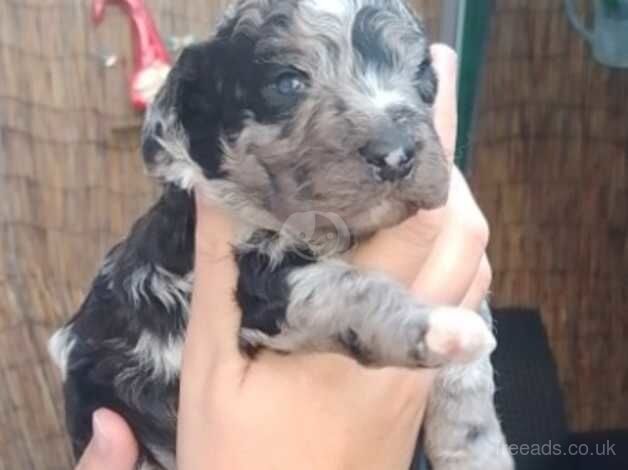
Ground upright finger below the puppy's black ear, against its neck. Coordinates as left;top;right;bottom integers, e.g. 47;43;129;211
183;196;243;386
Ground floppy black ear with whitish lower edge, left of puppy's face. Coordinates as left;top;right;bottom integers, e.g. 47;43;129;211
142;40;225;189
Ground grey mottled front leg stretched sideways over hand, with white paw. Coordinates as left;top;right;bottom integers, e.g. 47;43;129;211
242;262;495;367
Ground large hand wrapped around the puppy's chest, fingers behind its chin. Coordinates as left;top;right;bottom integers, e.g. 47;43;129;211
177;42;490;470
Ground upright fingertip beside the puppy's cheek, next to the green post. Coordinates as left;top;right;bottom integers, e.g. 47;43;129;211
430;44;458;162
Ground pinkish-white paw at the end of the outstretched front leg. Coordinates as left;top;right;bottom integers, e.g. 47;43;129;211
425;307;497;363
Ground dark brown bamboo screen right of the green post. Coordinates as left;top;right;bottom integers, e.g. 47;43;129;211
472;0;628;430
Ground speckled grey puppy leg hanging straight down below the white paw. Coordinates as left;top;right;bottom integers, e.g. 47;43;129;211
425;305;514;470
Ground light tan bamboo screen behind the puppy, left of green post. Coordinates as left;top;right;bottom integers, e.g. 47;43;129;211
0;0;440;470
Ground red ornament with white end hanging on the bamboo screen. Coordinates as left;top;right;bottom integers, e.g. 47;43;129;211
92;0;171;111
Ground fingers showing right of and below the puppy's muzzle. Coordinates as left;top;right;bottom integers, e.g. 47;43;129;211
354;45;492;310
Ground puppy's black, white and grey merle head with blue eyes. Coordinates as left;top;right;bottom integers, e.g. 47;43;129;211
143;0;449;241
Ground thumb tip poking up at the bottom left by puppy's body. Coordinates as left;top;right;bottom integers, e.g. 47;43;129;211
76;410;138;470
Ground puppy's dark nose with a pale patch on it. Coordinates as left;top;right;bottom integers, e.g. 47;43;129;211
360;132;416;181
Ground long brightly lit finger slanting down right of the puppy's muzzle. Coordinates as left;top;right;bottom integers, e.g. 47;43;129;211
413;169;489;305
